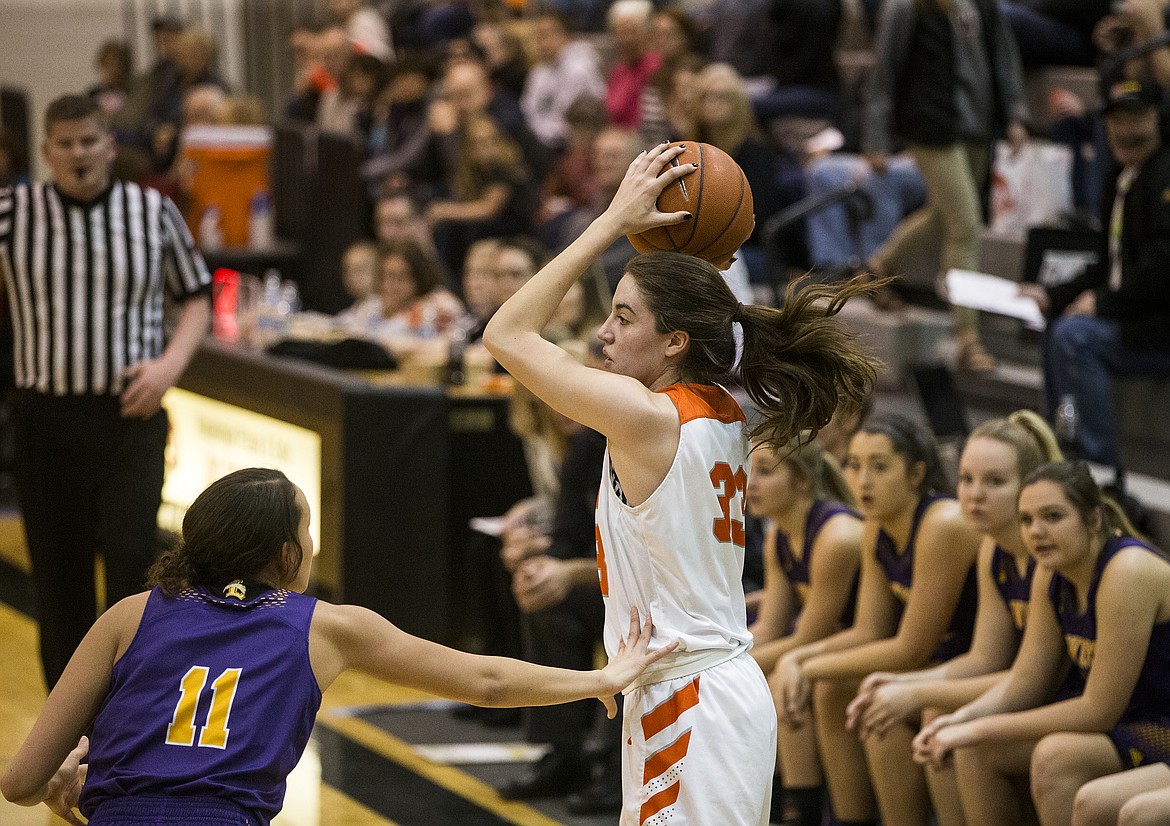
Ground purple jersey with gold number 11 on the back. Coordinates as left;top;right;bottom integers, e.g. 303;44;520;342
81;587;321;824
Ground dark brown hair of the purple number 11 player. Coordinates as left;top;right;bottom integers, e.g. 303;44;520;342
146;468;304;596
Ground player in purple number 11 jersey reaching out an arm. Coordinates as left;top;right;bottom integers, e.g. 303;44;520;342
0;468;674;826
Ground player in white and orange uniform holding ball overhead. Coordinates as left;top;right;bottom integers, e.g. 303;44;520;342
483;144;876;826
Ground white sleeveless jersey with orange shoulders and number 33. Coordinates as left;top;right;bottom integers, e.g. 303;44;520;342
597;385;751;686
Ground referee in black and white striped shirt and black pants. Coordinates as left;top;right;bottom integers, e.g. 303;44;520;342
0;95;211;688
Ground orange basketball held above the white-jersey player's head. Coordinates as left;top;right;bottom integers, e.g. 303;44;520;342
627;140;756;266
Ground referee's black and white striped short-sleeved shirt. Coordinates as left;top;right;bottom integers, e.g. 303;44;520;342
0;181;212;395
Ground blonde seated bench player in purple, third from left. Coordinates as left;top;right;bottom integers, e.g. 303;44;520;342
848;411;1061;826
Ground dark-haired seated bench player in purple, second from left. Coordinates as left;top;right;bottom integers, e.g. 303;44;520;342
772;415;979;824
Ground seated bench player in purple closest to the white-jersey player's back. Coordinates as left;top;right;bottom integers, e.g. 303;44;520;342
748;441;861;826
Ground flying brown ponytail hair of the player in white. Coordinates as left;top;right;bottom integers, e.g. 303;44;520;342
626;252;885;453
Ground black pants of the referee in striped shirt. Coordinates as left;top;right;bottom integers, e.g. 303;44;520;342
13;391;167;688
